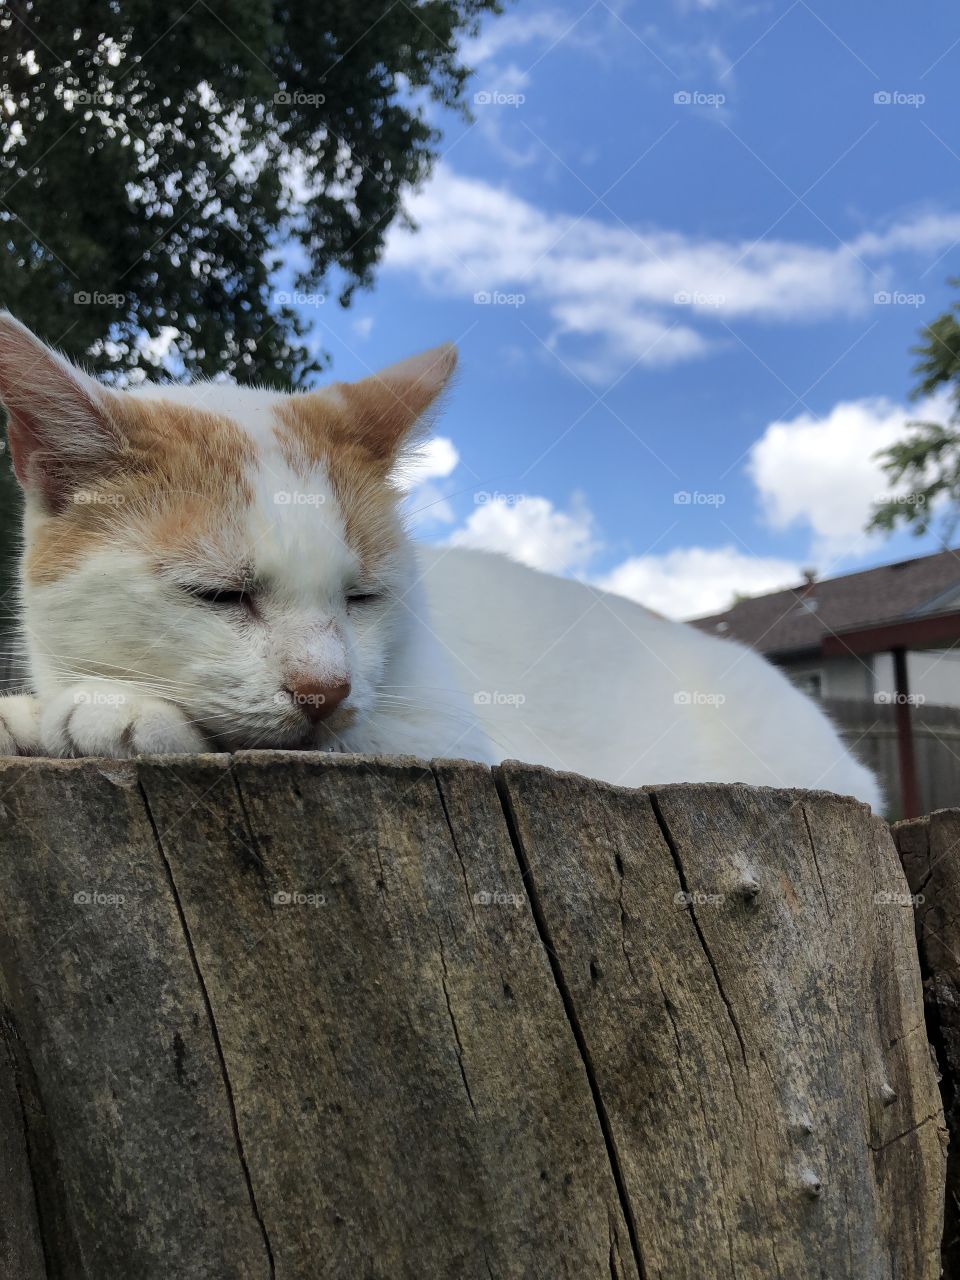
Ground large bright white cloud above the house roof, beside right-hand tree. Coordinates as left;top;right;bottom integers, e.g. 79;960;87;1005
748;397;950;556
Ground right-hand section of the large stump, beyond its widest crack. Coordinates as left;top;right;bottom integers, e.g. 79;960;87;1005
500;764;945;1280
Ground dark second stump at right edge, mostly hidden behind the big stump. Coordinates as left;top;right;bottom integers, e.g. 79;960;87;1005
893;809;960;1280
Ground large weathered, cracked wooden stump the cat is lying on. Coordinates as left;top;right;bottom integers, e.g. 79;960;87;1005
0;753;945;1280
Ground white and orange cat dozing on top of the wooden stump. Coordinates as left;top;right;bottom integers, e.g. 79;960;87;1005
0;314;881;809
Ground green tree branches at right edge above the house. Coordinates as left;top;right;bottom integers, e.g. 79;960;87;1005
868;278;960;539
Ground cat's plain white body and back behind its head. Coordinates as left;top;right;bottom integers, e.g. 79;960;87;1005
420;548;881;809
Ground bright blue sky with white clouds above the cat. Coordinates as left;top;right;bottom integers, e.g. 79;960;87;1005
293;0;960;617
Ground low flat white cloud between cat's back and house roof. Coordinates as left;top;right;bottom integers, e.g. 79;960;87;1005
595;547;801;618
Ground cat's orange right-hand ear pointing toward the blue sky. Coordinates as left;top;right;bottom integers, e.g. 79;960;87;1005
337;342;457;467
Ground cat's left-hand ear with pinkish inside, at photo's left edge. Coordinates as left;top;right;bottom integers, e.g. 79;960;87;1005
0;311;122;512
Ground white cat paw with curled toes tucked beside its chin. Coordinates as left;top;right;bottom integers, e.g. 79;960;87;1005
41;681;207;759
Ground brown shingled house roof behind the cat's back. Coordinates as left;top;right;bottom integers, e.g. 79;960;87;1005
692;548;960;654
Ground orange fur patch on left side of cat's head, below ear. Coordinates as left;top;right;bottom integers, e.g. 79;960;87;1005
24;396;256;582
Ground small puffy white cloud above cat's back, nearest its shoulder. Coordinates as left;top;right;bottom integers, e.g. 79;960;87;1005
449;494;600;573
